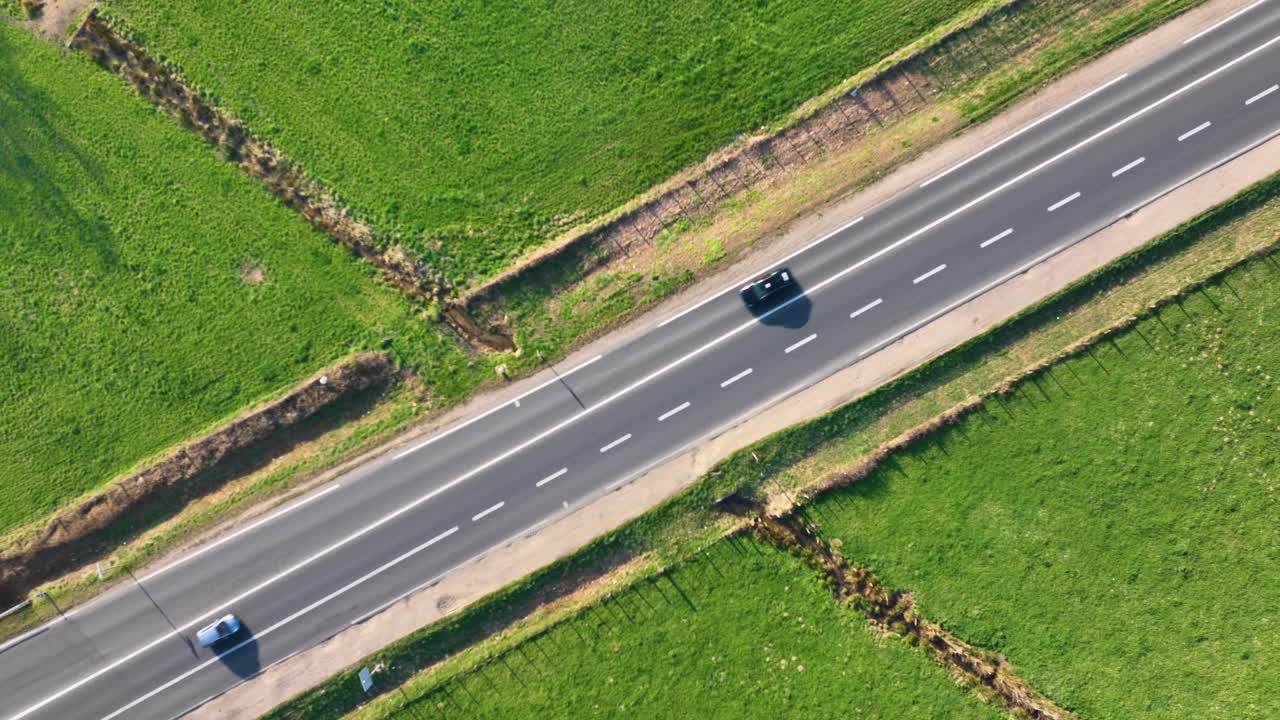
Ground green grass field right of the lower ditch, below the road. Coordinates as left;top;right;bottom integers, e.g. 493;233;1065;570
810;258;1280;720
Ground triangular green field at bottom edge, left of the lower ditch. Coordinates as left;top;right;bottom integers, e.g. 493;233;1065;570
353;536;1007;720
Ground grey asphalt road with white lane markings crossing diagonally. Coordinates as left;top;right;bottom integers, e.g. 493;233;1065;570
0;0;1280;720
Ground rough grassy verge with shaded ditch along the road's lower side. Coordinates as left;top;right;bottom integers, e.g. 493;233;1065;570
271;169;1280;720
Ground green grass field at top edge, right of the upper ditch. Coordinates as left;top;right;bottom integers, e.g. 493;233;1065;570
99;0;982;286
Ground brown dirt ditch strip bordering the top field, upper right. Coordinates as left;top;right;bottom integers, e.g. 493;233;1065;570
458;0;1198;319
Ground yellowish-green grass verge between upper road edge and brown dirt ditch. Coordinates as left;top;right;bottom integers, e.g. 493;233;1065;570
476;0;1201;368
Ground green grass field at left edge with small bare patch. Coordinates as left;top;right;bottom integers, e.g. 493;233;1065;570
0;23;478;532
